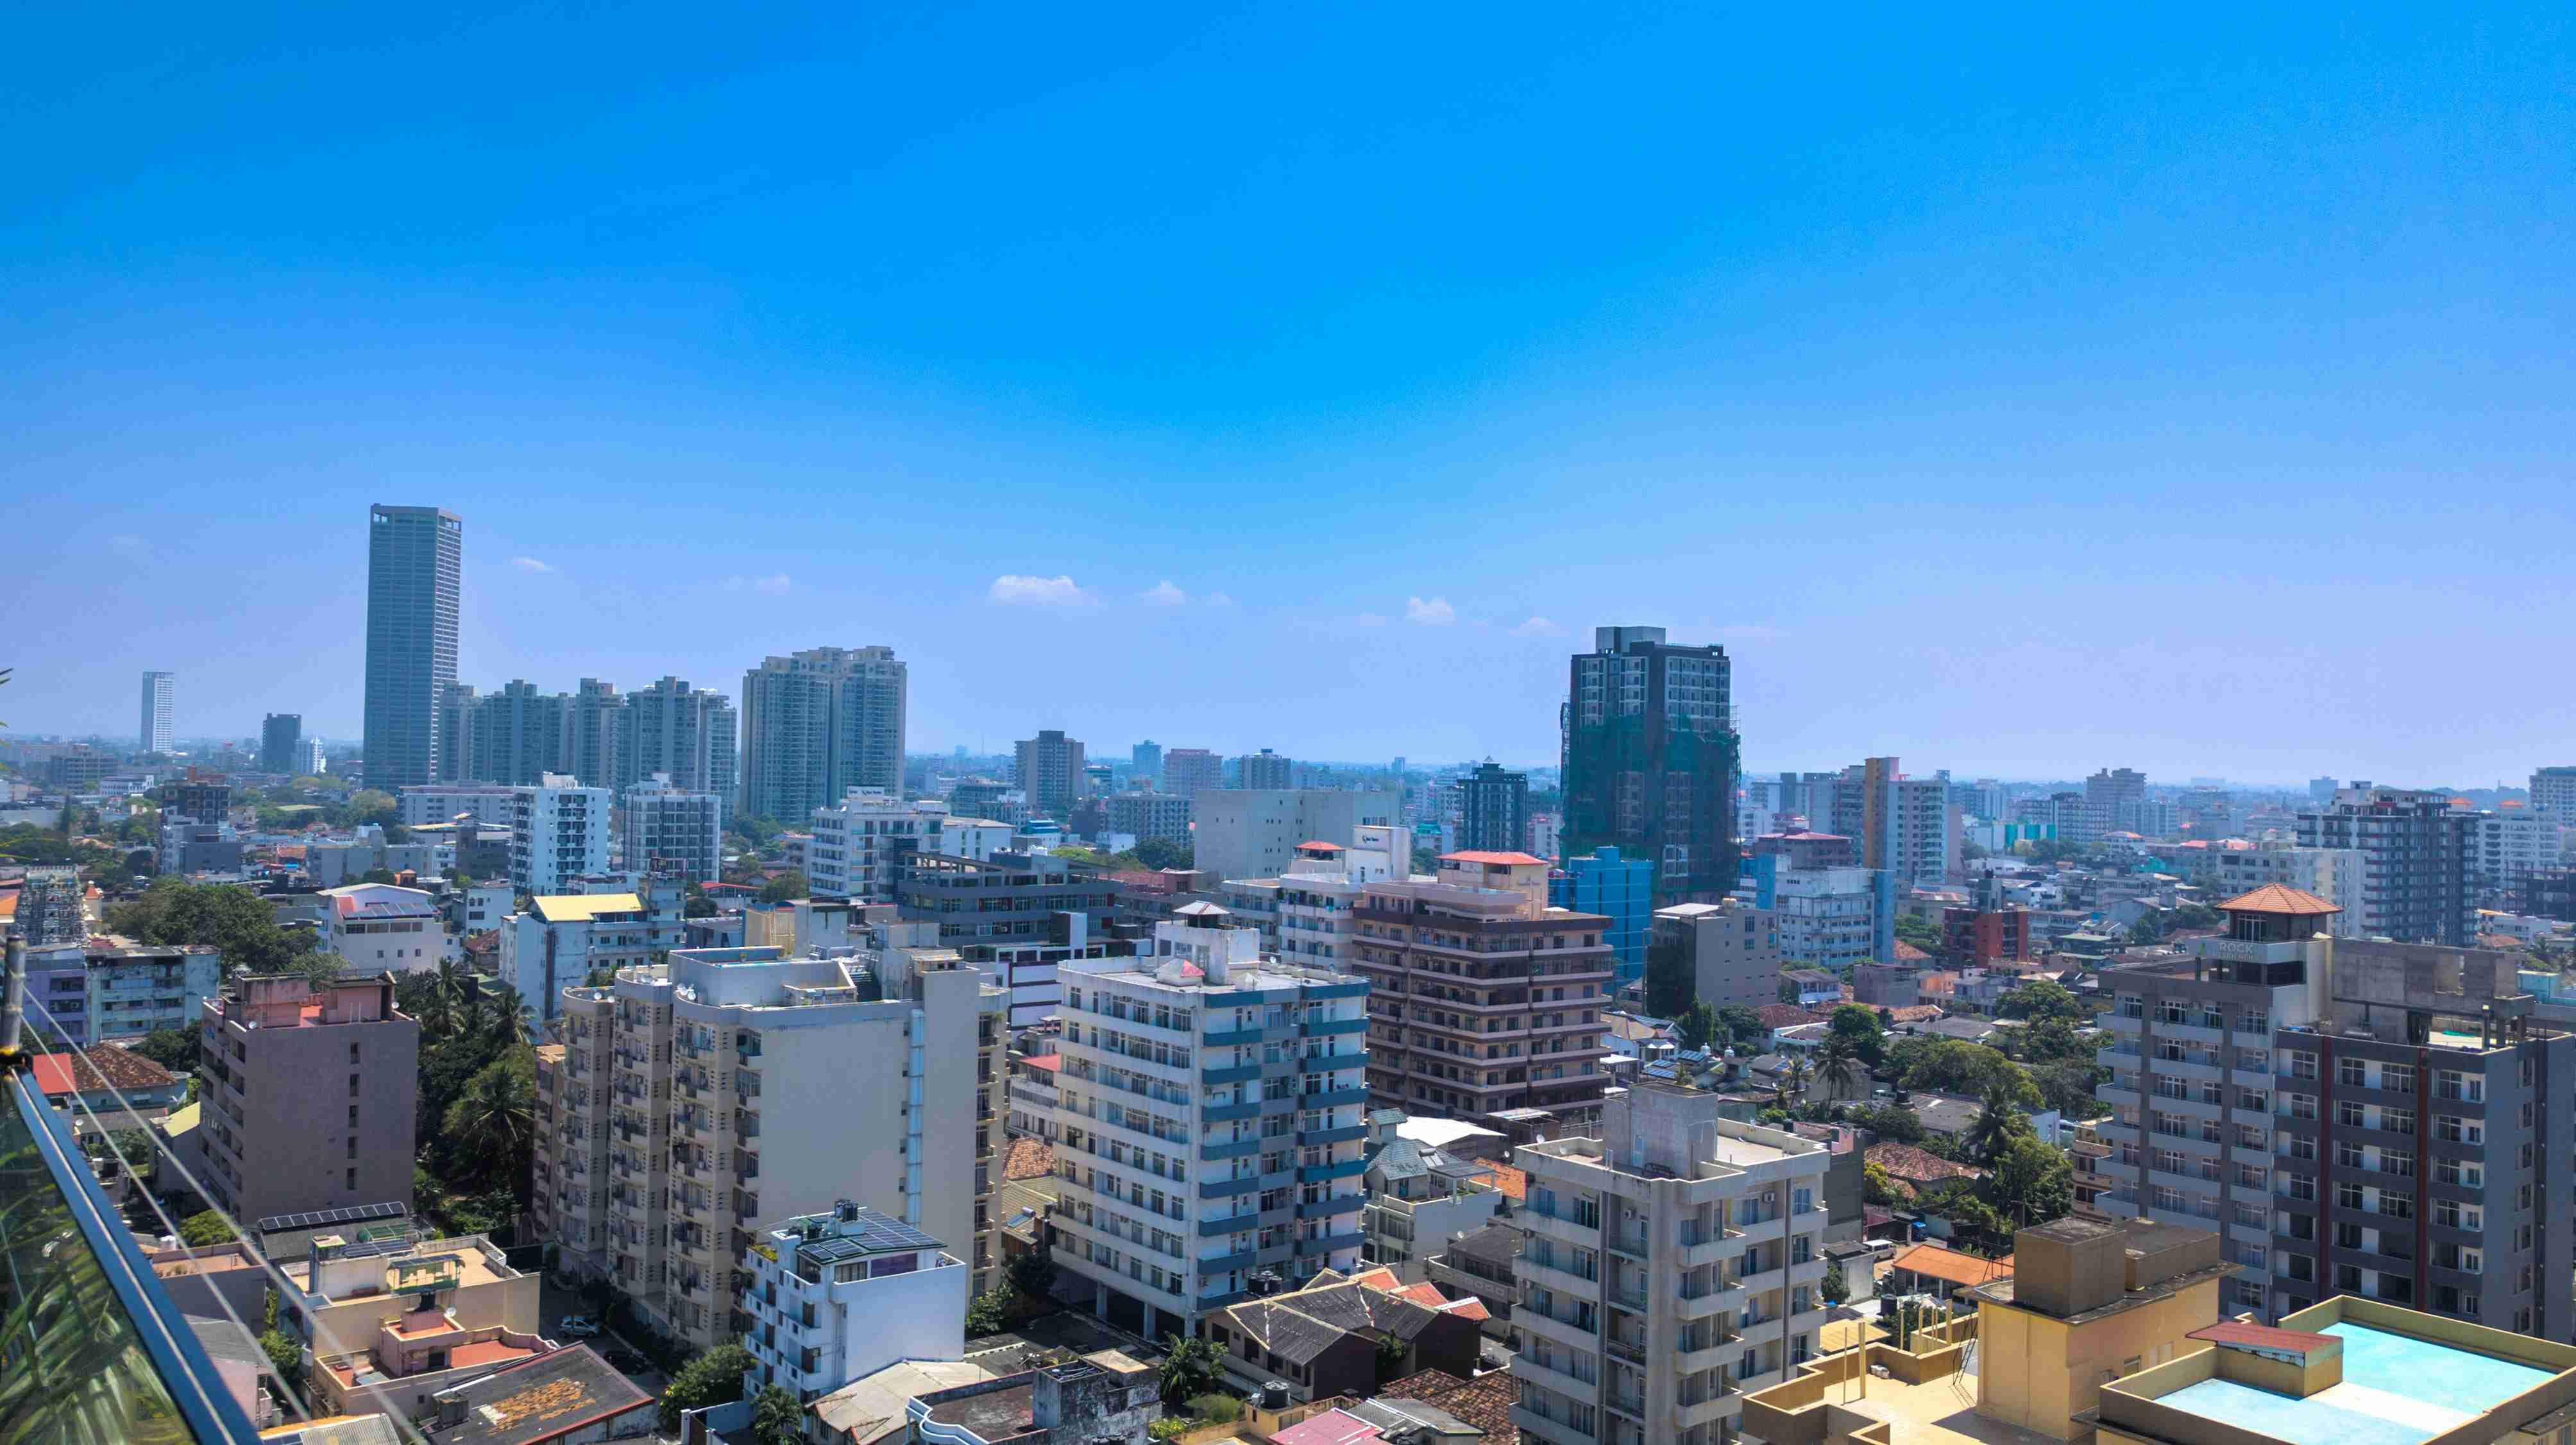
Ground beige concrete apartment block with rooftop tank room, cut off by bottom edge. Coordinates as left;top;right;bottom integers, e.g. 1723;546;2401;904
1512;1084;1829;1445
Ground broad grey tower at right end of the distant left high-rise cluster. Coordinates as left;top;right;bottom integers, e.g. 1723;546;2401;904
736;647;907;822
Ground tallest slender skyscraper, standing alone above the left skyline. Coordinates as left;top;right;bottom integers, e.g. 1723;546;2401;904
366;502;466;791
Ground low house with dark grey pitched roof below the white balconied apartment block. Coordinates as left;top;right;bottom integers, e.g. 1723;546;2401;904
1205;1270;1486;1401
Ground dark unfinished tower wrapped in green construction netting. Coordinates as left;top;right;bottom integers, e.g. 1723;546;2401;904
1561;626;1739;904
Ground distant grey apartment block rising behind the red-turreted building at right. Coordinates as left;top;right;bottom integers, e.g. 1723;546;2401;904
2298;788;2478;945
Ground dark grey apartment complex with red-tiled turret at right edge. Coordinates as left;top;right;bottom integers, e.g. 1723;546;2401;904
2076;886;2576;1339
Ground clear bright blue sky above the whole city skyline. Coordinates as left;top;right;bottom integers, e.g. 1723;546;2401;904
0;5;2576;783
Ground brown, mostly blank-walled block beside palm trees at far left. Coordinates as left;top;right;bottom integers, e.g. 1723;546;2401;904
196;973;420;1221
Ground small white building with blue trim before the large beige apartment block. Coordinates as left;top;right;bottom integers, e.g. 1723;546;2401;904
742;1201;974;1404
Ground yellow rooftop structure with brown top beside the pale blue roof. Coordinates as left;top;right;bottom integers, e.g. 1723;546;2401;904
1968;1218;2236;1440
